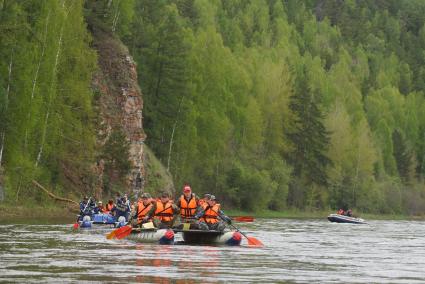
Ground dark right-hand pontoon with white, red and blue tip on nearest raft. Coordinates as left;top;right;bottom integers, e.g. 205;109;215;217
174;229;242;246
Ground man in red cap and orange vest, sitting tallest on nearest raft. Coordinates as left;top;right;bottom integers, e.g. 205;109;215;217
175;184;199;229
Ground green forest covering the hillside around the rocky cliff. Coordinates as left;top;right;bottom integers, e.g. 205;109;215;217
0;0;425;214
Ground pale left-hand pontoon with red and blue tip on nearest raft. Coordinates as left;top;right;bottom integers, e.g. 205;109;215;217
126;228;174;245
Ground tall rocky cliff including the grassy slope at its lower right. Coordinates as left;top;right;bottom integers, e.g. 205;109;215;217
89;21;174;198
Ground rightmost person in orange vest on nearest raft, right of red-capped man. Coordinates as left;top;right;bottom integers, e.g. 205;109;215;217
195;195;232;232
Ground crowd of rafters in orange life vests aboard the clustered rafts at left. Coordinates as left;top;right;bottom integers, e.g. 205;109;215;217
80;185;232;231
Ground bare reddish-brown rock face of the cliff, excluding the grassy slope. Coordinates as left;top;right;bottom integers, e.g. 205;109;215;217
92;27;146;197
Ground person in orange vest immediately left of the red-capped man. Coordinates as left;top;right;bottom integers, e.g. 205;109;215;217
153;191;179;229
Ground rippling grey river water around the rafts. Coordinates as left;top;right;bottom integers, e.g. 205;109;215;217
0;219;425;283
